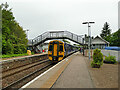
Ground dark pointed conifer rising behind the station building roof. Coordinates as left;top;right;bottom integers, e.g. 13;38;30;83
100;22;111;40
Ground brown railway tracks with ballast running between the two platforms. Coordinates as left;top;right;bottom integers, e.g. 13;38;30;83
2;59;53;90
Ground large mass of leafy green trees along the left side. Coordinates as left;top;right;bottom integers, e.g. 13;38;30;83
0;3;28;54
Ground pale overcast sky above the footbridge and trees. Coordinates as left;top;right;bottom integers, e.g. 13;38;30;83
0;0;119;39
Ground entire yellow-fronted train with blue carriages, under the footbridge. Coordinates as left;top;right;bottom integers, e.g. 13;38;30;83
48;40;78;62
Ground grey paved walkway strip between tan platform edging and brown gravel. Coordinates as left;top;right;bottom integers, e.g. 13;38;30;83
52;52;94;88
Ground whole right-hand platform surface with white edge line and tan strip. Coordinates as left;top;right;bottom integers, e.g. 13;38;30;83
22;52;94;90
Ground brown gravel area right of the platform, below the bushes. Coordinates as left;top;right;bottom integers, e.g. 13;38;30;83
85;57;118;88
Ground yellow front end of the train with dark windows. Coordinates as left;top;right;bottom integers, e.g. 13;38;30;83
48;40;64;62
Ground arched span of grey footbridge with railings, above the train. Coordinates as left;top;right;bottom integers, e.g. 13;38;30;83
32;31;83;46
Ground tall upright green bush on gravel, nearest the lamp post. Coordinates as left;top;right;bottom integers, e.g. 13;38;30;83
91;49;103;68
